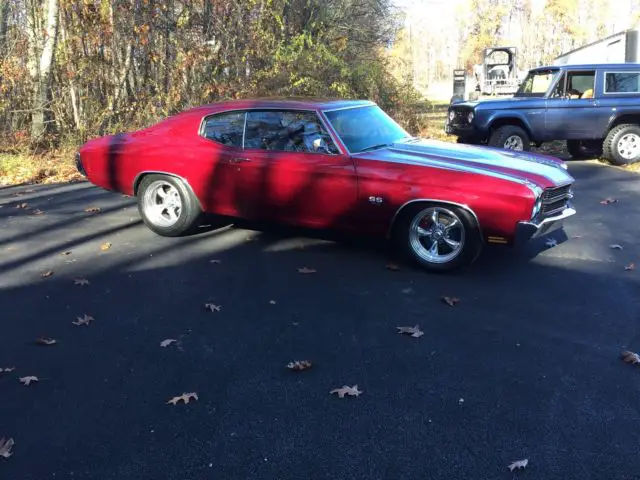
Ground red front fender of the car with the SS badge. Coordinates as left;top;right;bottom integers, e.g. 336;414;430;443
356;158;534;240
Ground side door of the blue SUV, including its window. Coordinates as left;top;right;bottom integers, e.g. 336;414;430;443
545;70;598;140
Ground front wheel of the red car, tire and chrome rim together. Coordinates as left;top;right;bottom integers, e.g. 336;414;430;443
394;203;482;272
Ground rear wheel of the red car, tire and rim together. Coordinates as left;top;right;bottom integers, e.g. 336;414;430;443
138;175;202;237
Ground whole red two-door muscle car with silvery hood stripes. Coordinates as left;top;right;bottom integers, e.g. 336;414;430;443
76;99;575;271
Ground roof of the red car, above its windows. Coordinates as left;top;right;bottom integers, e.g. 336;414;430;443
185;97;375;113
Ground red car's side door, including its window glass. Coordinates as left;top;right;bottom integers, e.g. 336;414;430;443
237;110;358;228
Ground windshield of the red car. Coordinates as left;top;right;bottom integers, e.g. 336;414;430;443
325;105;410;153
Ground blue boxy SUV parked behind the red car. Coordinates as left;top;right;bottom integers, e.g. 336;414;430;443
445;63;640;165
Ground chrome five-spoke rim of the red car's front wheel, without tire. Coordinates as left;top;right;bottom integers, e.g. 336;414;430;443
409;207;465;264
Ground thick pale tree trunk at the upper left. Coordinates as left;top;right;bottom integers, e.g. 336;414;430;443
31;0;58;142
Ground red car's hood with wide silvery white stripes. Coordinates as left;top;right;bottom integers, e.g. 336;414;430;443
365;139;574;188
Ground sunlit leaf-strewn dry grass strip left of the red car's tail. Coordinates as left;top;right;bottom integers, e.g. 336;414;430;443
0;147;82;185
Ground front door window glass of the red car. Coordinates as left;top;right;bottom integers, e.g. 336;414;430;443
244;110;339;154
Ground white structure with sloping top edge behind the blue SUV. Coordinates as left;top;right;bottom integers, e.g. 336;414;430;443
553;29;640;65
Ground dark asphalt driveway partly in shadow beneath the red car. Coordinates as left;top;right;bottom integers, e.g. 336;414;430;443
0;163;640;480
